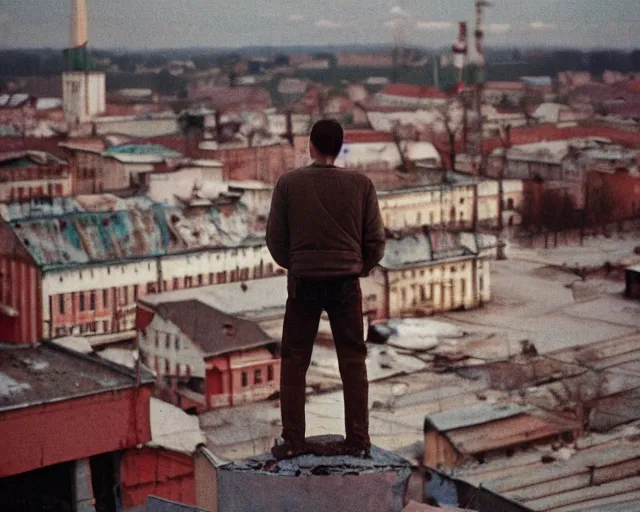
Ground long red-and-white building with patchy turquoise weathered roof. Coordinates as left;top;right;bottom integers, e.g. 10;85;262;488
0;198;276;343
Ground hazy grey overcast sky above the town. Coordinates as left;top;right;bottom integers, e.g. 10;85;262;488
0;0;640;49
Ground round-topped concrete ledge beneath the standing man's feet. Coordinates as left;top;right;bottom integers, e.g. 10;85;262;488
218;436;411;512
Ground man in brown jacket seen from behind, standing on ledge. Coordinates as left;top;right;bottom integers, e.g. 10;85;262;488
267;120;385;459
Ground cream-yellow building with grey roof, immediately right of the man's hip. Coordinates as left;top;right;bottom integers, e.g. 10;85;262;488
362;229;491;321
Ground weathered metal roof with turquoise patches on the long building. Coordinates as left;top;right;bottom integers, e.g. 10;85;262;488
11;203;260;268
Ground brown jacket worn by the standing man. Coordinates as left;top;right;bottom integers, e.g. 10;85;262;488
267;164;385;277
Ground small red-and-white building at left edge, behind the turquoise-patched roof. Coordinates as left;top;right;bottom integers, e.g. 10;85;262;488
0;151;74;203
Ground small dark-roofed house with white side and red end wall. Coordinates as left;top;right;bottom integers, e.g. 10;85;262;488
138;298;280;410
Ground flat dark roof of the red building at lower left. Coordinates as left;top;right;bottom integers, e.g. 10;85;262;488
0;345;150;411
